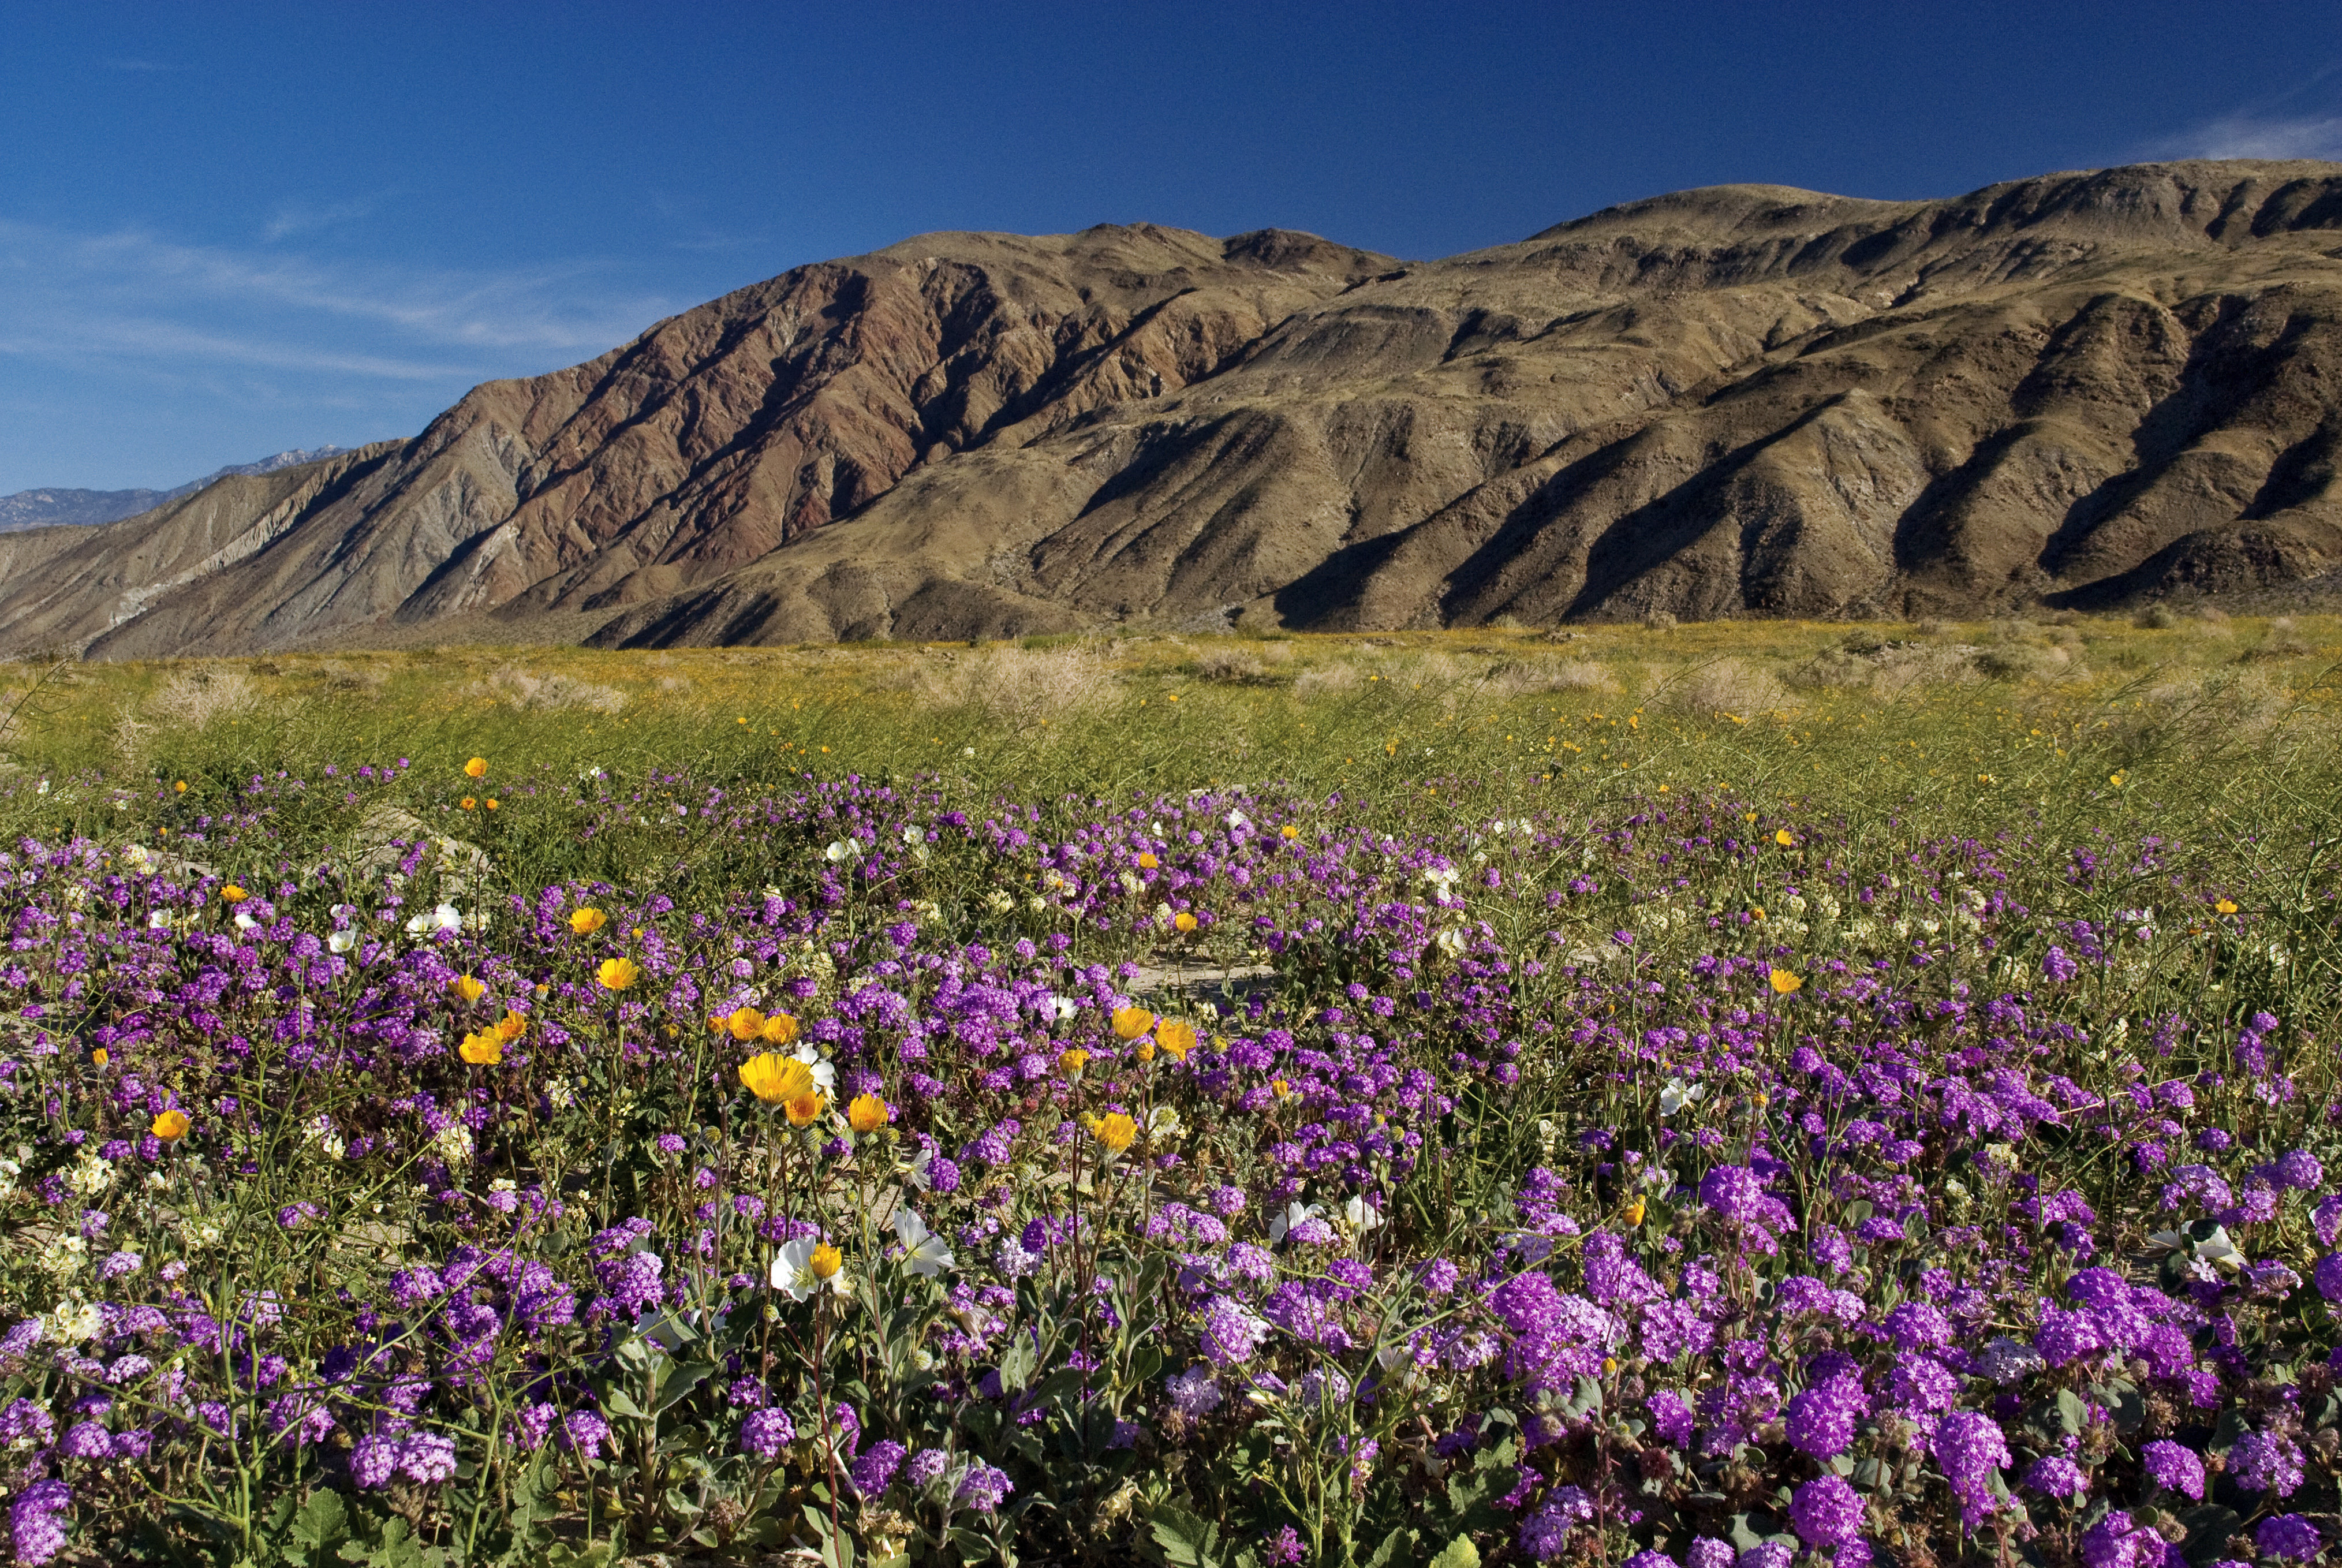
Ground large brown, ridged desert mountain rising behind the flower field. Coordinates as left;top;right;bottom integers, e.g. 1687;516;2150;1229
13;162;2342;656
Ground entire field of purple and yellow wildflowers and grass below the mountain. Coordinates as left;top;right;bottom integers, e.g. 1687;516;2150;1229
0;614;2342;1568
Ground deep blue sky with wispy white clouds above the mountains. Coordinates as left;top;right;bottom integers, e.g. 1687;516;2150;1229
0;0;2342;495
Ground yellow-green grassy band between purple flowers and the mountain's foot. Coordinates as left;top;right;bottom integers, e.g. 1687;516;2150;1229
0;612;2342;830
